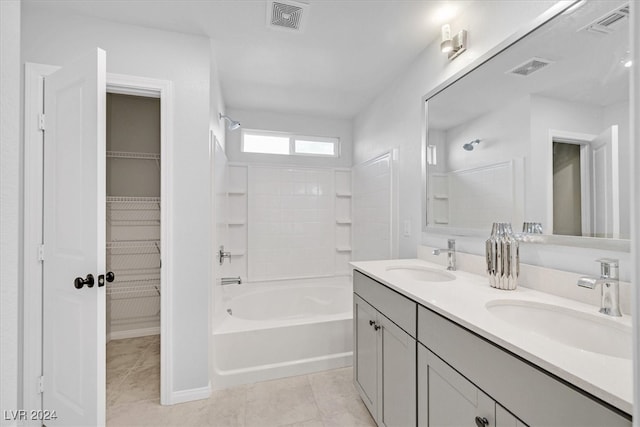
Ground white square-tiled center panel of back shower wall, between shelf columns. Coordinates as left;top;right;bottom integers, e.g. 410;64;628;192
248;166;335;280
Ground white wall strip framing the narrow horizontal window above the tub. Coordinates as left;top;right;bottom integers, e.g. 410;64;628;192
226;108;353;167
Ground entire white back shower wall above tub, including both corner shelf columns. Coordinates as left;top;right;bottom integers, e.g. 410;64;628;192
223;164;352;281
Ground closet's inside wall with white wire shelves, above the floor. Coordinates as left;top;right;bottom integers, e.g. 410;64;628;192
107;93;161;339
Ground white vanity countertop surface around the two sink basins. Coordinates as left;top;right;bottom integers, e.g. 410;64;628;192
351;259;633;414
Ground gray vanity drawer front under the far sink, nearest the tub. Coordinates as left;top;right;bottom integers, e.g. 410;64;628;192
353;270;417;338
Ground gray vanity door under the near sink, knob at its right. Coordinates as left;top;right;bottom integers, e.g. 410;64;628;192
418;345;495;427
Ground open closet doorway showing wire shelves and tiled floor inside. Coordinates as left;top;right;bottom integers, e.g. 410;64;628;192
106;91;162;408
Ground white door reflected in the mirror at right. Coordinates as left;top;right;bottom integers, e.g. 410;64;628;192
590;125;620;238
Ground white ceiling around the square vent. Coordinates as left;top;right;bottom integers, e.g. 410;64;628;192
23;0;469;118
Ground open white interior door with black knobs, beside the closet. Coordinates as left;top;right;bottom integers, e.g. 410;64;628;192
42;49;106;426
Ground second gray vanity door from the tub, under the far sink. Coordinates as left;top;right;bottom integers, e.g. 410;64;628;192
378;314;416;427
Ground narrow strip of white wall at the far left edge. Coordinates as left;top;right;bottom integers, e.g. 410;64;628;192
0;0;21;426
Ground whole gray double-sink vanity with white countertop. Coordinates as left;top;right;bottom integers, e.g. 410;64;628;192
352;260;632;427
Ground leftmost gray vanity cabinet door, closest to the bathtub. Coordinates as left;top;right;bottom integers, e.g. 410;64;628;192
353;294;378;418
